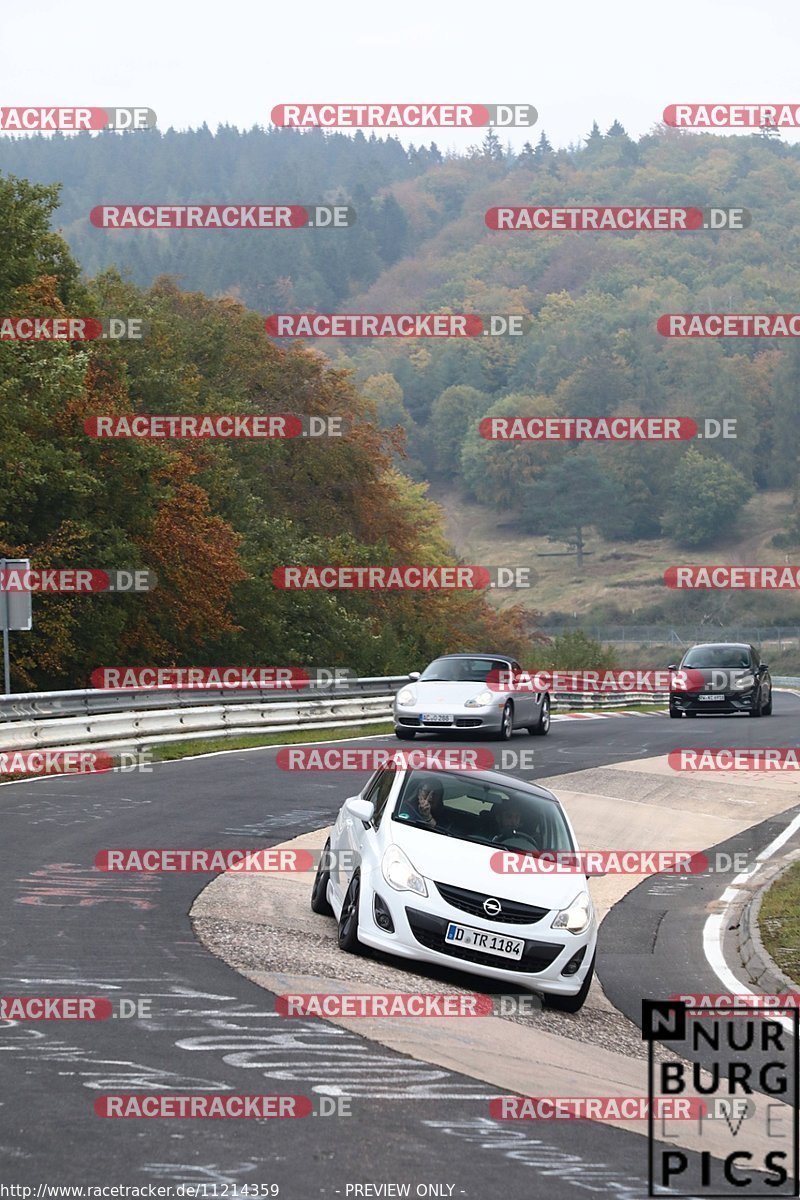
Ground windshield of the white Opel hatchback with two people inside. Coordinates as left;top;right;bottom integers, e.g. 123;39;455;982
392;770;575;851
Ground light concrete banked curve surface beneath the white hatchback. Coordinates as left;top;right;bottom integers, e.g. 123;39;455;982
191;756;800;1157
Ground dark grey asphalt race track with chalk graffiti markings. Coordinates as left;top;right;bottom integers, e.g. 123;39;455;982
0;694;800;1200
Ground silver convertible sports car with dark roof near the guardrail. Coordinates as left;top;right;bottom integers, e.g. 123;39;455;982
395;654;551;740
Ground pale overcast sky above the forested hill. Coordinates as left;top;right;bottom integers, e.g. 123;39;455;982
6;0;800;149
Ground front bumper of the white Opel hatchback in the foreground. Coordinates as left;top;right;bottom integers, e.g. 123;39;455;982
359;871;597;996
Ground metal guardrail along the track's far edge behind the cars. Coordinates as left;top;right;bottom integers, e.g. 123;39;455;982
0;676;800;750
